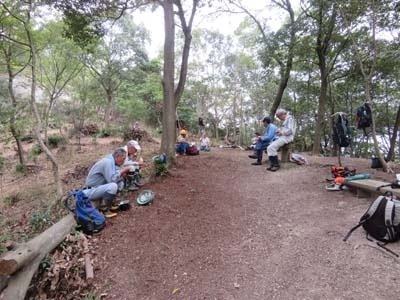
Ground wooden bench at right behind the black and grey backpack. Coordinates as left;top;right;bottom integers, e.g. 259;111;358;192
344;179;400;198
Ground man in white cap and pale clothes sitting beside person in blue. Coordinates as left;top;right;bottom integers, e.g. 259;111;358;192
267;108;296;172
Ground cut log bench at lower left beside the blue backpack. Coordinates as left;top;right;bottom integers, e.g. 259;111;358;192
0;214;76;300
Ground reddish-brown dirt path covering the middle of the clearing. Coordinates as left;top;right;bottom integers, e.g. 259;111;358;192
94;149;400;300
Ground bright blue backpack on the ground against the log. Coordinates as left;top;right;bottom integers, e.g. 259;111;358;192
64;190;106;234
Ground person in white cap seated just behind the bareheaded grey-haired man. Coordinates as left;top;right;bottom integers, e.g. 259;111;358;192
122;140;143;191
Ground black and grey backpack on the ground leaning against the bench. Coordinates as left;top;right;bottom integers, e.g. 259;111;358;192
343;192;400;256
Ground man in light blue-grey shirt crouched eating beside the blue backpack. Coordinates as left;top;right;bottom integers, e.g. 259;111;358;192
83;148;130;218
